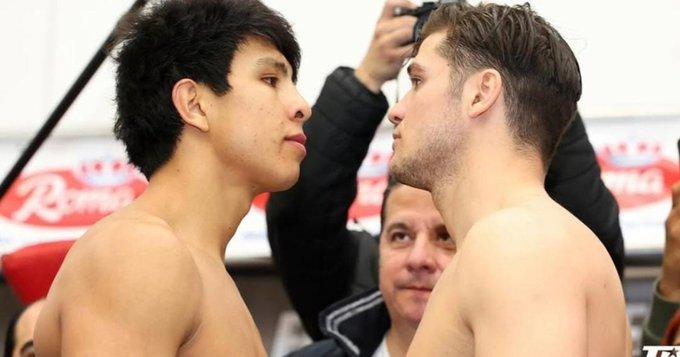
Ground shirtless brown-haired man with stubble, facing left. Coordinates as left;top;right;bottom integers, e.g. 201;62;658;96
389;4;630;357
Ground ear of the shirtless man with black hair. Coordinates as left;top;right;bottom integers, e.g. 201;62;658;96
172;78;210;132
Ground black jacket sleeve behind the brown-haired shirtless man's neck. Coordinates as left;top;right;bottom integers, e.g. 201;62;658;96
545;113;624;277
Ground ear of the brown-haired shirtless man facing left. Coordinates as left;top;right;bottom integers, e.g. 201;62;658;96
464;69;503;118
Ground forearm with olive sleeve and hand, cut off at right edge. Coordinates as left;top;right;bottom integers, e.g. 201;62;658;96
641;182;680;346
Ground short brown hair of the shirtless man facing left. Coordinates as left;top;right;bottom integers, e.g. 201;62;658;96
415;4;581;168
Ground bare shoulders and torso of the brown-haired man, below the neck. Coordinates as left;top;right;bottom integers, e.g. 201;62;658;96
409;196;630;356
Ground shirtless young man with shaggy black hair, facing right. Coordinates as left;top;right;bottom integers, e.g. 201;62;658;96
35;0;310;356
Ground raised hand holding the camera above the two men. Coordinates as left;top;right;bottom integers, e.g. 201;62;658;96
355;0;417;93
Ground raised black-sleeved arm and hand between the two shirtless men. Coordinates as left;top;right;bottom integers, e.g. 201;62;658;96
267;0;415;339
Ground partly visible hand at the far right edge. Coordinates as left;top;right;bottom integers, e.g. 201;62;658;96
659;182;680;302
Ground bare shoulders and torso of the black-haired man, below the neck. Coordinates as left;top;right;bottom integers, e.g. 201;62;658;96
36;208;265;356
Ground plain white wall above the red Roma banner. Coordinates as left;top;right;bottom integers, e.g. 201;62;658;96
0;0;680;138
